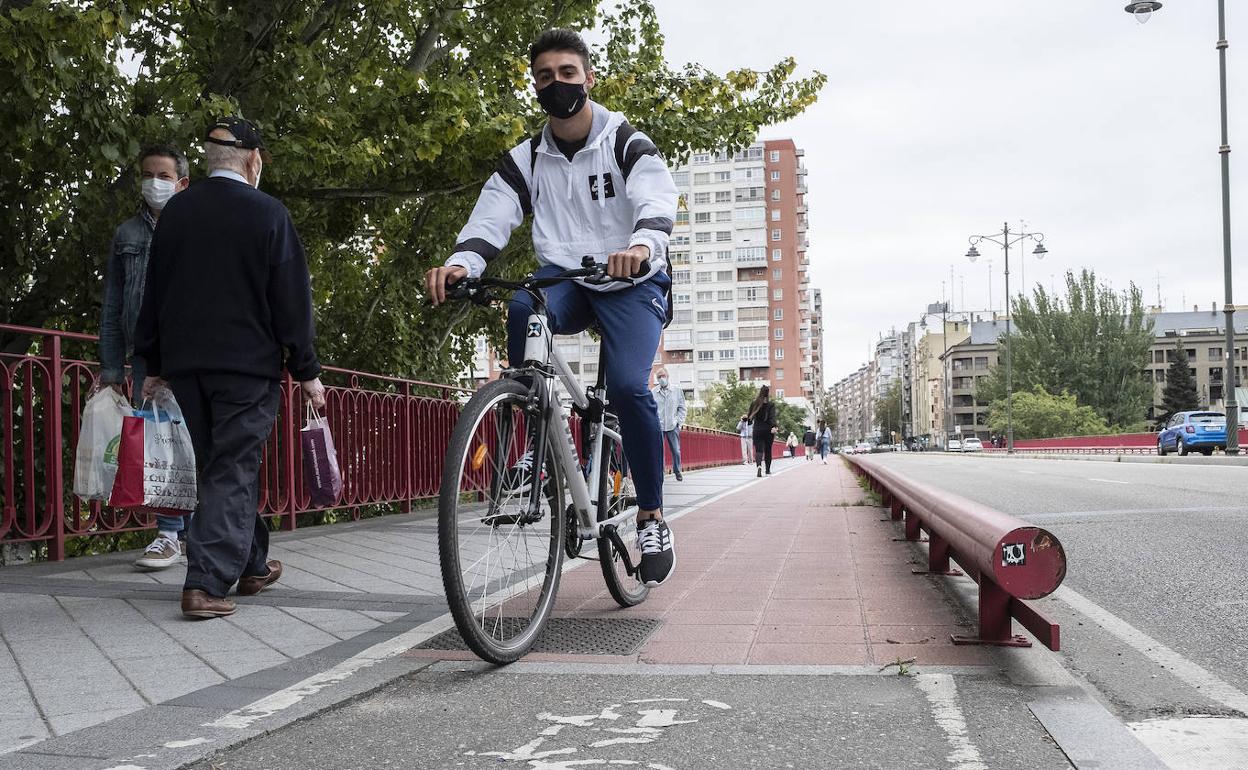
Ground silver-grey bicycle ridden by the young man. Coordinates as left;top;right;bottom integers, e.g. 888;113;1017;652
438;257;650;665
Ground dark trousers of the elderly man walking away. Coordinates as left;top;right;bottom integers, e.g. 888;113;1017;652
168;374;280;597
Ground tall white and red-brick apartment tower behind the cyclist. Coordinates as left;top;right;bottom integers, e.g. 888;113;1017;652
661;140;822;408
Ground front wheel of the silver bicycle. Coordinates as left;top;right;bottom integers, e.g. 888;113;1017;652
438;379;564;664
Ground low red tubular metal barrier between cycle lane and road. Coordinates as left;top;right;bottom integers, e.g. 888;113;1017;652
846;456;1066;651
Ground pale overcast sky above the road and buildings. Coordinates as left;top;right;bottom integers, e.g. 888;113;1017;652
655;0;1248;384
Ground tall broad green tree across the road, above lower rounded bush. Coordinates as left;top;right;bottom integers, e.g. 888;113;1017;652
980;270;1153;426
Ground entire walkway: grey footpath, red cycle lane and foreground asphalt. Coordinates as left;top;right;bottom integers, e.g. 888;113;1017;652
0;458;1133;770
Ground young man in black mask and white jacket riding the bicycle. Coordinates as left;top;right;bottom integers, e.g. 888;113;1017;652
426;30;676;585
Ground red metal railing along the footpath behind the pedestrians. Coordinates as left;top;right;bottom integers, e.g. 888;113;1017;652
0;324;741;559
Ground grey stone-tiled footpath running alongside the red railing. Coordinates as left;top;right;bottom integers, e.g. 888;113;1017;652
0;461;797;768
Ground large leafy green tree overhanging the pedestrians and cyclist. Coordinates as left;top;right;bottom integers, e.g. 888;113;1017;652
0;0;825;381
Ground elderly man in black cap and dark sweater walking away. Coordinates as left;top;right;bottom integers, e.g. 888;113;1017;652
135;117;324;618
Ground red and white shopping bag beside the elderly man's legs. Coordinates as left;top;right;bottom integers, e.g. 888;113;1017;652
109;392;197;515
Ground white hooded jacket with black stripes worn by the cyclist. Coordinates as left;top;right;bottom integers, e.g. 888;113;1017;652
447;102;676;291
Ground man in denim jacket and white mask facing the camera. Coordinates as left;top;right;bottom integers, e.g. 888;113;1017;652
100;145;191;570
